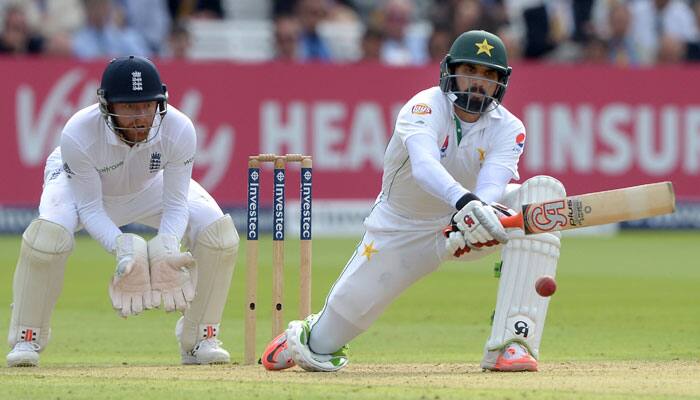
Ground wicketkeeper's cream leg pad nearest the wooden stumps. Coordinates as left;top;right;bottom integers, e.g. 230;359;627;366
178;214;239;351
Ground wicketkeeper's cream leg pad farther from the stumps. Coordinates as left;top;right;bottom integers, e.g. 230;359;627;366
7;219;73;349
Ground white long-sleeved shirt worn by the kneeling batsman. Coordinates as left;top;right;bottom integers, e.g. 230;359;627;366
380;87;525;219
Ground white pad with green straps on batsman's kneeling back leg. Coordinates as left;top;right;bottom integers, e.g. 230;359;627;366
285;314;348;372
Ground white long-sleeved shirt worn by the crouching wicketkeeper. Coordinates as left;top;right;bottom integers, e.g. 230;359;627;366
60;104;197;252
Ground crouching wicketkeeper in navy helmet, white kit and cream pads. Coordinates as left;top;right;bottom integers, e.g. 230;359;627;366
7;56;238;367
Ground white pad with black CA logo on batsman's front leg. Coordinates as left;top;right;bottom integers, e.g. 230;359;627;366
482;176;566;368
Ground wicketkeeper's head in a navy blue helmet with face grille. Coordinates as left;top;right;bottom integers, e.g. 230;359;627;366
97;56;168;146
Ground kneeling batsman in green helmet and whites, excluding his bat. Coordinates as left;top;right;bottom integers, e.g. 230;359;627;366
262;31;566;371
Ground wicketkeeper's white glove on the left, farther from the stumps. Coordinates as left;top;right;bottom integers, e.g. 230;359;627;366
109;233;153;318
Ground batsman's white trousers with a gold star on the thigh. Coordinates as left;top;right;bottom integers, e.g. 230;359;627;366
322;202;501;332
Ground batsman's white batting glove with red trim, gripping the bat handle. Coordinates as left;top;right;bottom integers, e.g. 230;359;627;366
453;200;508;249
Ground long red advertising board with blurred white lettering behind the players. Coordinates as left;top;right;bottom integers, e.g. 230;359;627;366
0;59;700;206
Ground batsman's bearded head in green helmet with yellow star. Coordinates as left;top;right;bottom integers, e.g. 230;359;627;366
440;31;512;114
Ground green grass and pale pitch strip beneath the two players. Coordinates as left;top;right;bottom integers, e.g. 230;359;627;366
0;232;700;399
